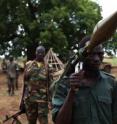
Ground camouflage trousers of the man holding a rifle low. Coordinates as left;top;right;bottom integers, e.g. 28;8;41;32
25;100;48;124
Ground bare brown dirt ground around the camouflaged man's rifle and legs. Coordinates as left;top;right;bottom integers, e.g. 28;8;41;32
0;73;52;124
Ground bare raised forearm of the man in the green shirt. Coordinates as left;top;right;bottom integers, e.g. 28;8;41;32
55;89;74;124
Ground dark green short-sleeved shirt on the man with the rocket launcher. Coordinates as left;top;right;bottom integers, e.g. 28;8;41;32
52;72;117;124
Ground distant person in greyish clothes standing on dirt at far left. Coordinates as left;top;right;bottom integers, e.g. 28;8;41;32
7;56;17;96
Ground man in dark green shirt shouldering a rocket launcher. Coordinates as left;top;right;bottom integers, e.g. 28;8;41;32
52;38;117;124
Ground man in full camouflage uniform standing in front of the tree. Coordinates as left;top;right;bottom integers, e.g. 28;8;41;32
20;46;49;124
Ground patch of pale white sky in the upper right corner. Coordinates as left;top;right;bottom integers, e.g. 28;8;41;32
93;0;117;18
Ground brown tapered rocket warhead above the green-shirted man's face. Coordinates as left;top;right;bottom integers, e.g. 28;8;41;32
87;11;117;52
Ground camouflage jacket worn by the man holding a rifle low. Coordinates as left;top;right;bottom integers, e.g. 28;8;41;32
24;61;49;102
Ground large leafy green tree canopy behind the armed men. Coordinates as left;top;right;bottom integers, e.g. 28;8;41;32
0;0;101;59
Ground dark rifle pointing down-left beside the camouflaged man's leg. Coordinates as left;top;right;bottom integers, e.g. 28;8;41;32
3;111;24;124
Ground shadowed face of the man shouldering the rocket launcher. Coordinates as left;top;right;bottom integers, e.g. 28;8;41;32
84;45;104;70
